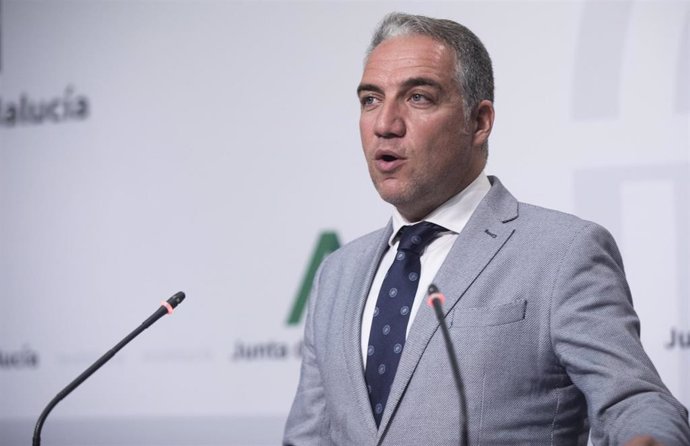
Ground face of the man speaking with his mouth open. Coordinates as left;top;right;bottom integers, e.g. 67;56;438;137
357;35;485;221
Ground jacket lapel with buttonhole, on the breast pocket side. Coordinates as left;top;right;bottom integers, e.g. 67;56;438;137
377;177;518;444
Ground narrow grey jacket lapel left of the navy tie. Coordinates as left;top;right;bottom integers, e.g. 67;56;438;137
343;223;393;438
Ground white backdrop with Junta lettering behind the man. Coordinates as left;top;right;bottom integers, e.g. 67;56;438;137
0;0;690;446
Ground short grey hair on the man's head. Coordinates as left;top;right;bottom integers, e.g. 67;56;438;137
367;12;494;120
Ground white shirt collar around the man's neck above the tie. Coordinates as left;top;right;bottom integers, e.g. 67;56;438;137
388;171;491;247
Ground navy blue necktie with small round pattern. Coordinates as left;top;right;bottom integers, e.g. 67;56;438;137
364;221;446;426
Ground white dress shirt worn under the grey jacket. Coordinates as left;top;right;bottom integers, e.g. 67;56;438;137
361;172;491;367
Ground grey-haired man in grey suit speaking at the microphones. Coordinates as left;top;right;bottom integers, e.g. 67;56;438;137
284;14;690;446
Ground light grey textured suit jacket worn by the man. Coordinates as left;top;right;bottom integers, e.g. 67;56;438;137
284;178;690;446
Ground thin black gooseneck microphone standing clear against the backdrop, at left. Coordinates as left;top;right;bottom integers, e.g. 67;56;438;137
33;291;185;446
